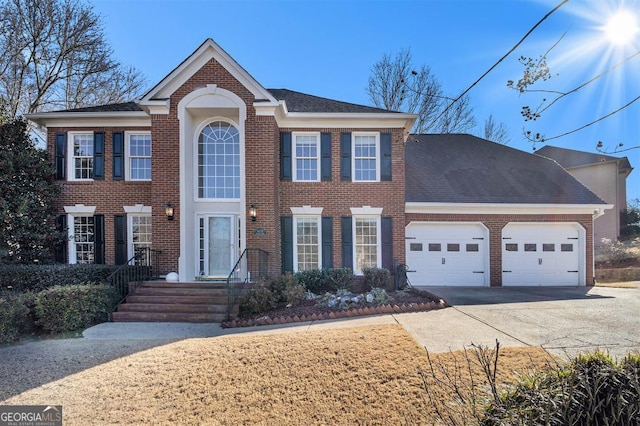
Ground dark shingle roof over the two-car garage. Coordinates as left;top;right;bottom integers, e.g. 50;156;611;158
405;134;604;204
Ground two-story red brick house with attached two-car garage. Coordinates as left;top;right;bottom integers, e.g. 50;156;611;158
28;39;608;286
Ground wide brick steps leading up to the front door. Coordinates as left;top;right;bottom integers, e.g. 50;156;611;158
111;281;232;323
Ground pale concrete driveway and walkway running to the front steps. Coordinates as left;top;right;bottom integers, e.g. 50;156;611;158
83;287;640;356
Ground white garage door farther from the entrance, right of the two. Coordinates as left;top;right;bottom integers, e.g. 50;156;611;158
502;223;584;286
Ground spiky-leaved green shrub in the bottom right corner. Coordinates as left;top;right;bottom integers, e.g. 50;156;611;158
483;351;640;425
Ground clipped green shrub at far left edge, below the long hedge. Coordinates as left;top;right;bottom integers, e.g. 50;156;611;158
0;293;34;343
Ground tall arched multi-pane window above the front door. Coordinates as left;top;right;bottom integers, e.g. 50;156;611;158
198;121;240;199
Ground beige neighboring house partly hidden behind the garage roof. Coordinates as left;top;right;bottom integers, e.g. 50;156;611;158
536;145;633;246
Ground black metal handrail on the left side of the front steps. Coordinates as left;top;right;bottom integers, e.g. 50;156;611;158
106;247;162;311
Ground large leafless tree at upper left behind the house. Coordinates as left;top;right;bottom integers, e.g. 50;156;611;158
0;0;145;117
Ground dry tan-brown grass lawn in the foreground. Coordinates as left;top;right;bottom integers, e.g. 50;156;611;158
3;325;549;425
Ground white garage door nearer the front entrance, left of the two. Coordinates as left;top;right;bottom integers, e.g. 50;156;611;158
406;222;489;286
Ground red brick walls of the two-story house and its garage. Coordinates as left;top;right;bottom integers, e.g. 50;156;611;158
42;40;593;286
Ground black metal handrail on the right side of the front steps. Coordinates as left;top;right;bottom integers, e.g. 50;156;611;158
227;248;269;321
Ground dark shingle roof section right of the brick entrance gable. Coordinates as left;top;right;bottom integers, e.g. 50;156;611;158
267;89;396;113
